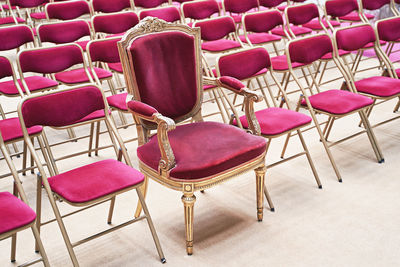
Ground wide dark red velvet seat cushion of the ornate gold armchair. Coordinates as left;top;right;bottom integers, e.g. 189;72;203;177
137;122;266;181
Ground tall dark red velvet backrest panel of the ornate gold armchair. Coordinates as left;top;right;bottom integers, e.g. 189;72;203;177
129;31;198;119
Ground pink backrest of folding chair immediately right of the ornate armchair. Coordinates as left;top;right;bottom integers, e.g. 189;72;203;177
218;47;271;80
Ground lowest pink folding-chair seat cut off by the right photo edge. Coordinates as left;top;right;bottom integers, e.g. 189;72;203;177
355;76;400;97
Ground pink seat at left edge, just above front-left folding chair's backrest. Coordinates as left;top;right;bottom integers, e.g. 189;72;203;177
0;76;58;96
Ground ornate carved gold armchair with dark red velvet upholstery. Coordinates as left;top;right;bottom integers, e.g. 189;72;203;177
118;18;269;255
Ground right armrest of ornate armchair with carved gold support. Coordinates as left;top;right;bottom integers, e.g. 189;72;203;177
203;76;263;135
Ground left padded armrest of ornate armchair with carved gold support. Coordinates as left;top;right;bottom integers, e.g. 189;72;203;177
127;100;176;174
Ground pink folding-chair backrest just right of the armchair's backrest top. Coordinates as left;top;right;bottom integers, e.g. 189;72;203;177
195;17;236;41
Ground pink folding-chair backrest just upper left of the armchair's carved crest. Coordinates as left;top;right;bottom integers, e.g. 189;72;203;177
92;12;139;34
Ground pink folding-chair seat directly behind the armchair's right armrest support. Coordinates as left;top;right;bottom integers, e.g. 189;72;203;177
233;107;312;136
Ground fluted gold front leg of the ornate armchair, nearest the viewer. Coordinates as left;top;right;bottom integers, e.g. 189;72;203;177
181;192;196;255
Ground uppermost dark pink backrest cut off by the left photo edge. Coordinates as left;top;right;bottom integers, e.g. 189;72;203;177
0;25;34;51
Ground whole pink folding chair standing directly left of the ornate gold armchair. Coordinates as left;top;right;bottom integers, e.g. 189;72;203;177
18;85;165;266
